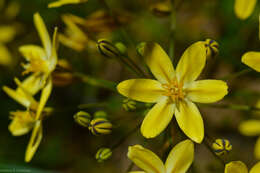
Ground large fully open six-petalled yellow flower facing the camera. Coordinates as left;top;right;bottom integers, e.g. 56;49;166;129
117;42;228;143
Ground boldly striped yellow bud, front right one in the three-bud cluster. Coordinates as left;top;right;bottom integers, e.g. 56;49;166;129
89;118;112;135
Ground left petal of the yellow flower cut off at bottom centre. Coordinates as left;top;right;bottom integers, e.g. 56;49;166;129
127;145;165;173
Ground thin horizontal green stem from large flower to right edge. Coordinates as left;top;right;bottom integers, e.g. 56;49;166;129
200;104;260;111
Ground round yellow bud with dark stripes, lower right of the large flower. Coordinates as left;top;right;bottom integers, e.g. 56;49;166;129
212;139;232;156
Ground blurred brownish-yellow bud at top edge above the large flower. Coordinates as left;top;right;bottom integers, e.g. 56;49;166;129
150;1;172;17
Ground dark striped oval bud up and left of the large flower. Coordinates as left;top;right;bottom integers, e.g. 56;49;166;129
97;39;121;58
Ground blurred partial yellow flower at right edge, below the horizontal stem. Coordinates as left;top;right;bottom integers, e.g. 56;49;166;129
238;101;260;159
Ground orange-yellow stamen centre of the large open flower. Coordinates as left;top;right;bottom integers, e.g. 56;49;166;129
162;78;185;102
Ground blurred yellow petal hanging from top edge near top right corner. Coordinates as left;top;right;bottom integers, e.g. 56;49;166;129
234;0;257;20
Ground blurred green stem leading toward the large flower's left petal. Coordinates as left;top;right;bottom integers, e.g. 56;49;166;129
74;72;117;91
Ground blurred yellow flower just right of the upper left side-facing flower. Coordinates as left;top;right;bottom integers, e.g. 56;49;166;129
59;15;88;51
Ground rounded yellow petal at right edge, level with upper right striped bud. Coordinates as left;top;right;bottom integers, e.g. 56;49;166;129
242;52;260;72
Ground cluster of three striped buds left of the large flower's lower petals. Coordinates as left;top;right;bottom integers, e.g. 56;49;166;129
74;111;113;135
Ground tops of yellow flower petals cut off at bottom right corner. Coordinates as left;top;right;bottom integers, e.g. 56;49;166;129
225;161;260;173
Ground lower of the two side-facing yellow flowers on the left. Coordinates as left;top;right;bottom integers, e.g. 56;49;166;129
3;74;50;162
